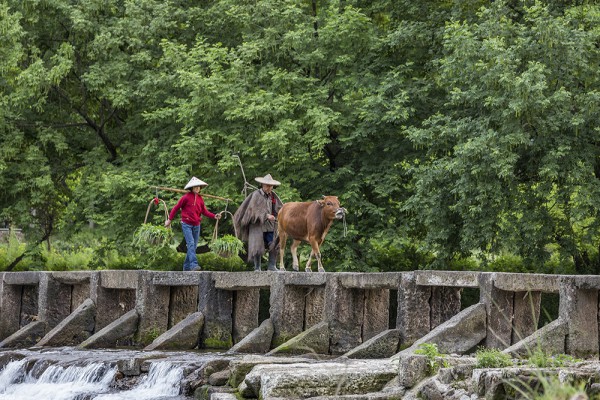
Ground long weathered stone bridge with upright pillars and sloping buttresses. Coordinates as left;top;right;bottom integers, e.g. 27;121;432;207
0;271;600;358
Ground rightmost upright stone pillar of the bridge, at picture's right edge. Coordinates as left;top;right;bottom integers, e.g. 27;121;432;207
558;277;598;357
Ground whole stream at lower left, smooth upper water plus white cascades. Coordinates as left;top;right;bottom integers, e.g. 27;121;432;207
0;348;227;400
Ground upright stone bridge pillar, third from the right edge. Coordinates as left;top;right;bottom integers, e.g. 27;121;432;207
396;273;431;345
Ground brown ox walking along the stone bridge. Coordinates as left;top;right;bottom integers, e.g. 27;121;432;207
277;196;346;272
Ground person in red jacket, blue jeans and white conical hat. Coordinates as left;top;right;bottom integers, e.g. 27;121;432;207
165;176;221;271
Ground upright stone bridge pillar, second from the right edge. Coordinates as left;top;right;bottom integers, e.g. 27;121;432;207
479;273;514;350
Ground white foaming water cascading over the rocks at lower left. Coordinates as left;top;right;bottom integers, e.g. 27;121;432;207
0;359;183;400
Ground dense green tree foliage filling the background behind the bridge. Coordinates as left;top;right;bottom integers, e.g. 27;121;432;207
0;0;600;273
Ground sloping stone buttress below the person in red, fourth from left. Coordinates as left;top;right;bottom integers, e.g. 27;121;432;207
144;312;204;350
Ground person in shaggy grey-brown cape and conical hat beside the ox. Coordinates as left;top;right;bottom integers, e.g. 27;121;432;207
233;174;283;271
